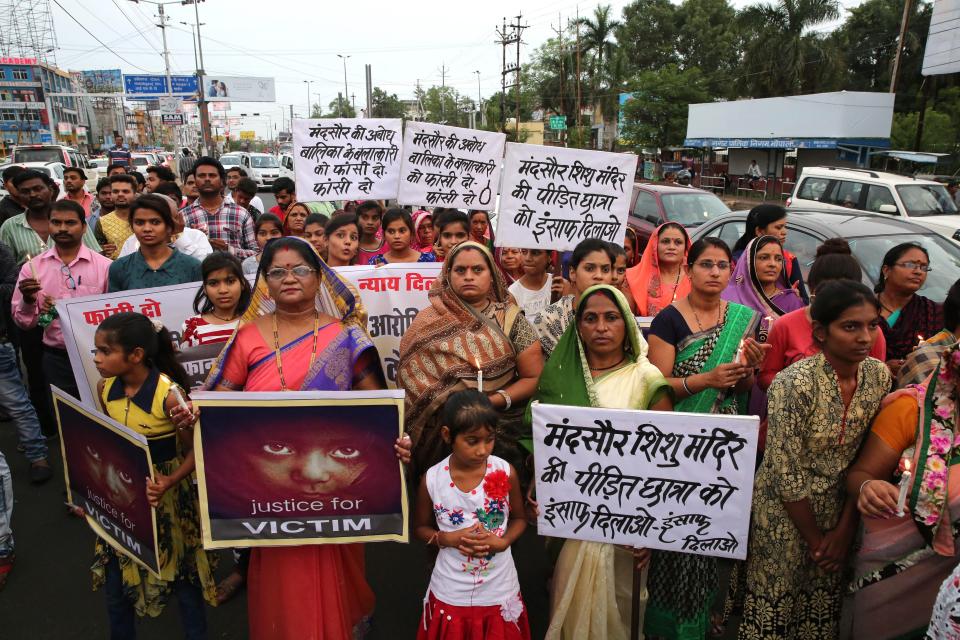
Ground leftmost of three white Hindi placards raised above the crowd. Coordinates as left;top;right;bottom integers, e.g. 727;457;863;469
293;118;403;201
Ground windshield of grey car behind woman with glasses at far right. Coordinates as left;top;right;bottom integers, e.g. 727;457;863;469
849;233;960;300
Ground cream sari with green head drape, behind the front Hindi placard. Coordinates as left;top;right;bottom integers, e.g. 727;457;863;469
535;285;670;640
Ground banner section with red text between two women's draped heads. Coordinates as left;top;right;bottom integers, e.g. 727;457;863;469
337;262;443;389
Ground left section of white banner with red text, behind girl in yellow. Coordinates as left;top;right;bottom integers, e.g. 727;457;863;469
57;282;209;407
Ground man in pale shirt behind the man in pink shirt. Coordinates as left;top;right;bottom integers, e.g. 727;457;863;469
0;169;100;435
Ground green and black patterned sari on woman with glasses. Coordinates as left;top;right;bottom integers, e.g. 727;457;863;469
644;303;759;640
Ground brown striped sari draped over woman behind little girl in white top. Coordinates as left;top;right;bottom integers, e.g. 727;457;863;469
397;241;536;476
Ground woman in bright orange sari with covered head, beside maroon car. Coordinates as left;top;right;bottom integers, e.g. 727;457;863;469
627;222;690;317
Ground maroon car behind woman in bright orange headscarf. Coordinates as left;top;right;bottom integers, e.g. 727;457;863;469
627;182;730;251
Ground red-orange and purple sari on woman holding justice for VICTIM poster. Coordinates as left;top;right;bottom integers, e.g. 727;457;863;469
204;241;379;640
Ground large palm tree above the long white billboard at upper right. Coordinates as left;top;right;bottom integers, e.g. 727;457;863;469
740;0;840;97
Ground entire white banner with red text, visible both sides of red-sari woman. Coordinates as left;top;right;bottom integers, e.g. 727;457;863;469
57;262;442;407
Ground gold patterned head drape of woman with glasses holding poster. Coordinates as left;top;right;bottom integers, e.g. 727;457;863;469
203;236;370;390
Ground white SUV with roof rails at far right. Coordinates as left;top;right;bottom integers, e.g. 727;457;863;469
787;167;960;243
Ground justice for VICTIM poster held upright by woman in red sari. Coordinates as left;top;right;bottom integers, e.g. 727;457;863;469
193;391;408;549
